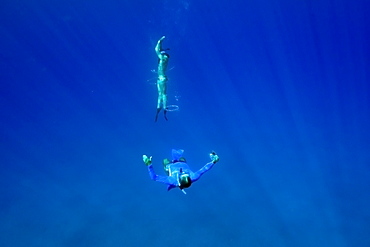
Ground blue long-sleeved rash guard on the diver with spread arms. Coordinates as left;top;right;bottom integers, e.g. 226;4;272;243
148;162;214;190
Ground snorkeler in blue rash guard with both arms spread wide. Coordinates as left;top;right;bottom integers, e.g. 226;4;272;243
143;149;220;194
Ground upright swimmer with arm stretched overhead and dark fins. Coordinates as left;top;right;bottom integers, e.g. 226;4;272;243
155;36;170;122
